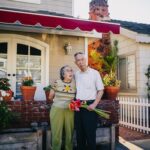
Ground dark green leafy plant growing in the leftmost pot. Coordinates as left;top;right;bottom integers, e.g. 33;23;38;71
0;78;10;91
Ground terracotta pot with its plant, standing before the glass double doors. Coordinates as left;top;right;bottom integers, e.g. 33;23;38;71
20;77;36;101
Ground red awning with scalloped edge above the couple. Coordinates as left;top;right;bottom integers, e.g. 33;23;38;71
0;9;120;34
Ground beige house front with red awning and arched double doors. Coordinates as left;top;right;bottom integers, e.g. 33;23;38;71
0;0;119;100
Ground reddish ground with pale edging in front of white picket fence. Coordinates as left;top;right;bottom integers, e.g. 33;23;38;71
119;127;150;150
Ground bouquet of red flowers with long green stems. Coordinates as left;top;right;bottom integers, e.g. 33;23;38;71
69;99;110;119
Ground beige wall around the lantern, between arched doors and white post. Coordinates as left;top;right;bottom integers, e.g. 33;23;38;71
50;35;85;82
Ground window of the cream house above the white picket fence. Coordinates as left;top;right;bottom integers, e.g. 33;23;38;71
119;55;136;91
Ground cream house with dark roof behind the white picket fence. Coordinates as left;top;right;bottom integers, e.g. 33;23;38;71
111;21;150;98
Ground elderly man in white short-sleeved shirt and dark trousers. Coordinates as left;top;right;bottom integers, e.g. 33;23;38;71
74;52;104;150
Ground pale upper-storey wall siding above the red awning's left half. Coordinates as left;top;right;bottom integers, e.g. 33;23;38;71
0;0;73;16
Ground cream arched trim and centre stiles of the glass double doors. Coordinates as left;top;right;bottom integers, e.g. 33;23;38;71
0;34;49;99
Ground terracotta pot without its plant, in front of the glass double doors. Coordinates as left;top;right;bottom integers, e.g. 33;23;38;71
20;86;36;101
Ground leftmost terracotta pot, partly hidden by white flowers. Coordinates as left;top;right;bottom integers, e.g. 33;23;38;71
0;90;13;101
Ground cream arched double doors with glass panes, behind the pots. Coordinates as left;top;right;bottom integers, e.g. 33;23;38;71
0;37;48;100
